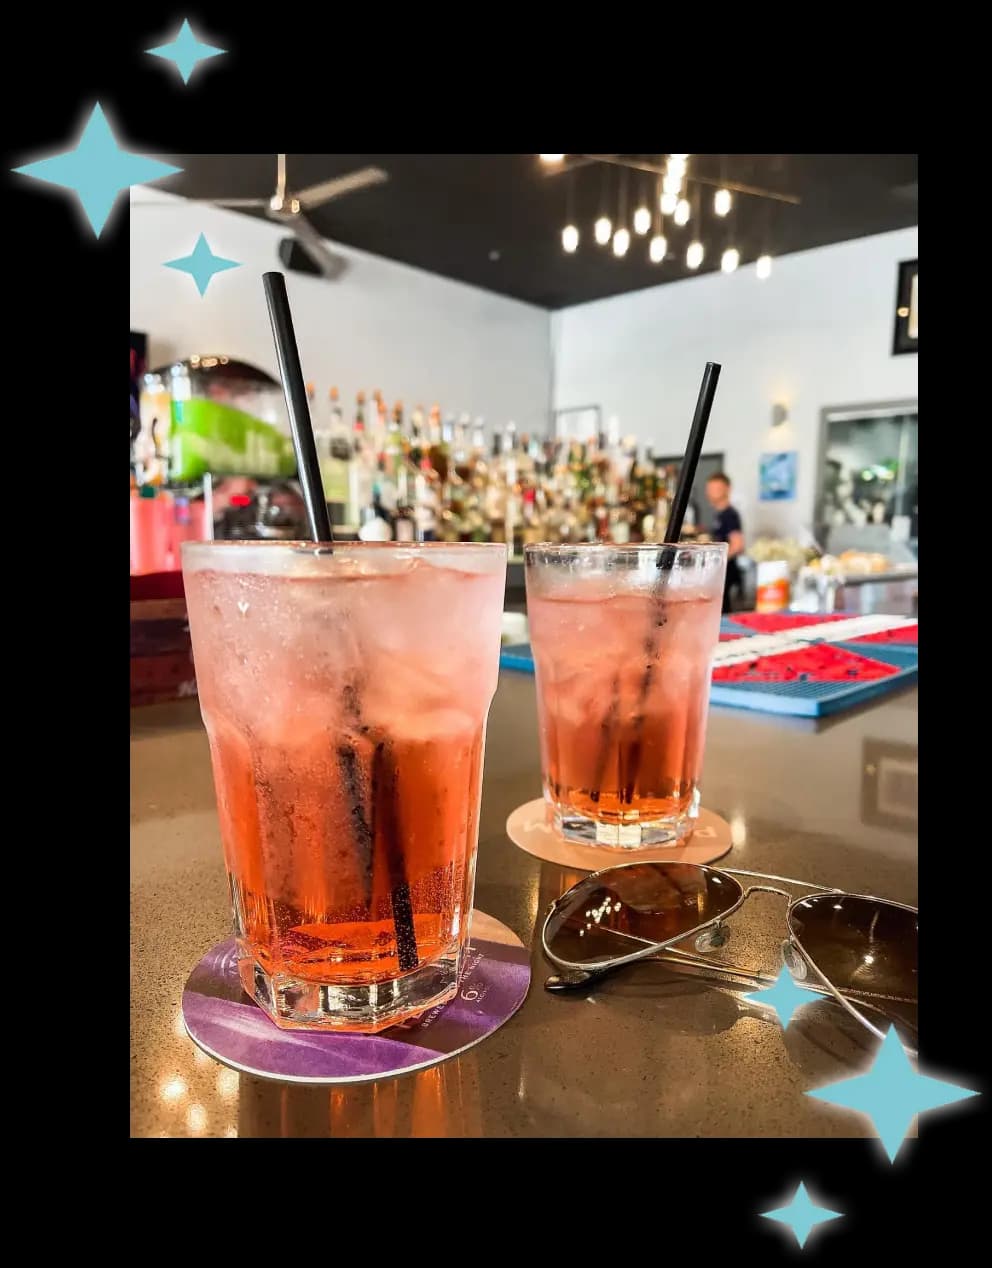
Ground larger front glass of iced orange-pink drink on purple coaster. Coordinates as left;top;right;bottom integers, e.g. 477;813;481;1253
183;541;506;1032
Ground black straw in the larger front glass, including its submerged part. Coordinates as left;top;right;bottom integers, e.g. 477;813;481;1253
261;273;419;971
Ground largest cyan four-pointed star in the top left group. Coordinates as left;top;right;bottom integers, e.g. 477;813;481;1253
14;101;183;237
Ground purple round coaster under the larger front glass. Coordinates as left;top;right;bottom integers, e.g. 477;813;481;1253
183;912;530;1083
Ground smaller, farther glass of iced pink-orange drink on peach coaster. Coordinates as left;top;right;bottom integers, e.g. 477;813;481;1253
525;544;727;850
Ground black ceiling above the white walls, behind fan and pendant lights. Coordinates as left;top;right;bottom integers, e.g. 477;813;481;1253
166;155;917;308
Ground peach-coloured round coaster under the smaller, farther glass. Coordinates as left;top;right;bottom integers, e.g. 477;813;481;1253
506;798;732;871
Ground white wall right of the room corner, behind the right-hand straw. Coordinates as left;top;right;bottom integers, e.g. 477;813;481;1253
552;228;918;538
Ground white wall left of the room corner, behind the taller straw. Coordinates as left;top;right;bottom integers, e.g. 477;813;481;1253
131;188;551;435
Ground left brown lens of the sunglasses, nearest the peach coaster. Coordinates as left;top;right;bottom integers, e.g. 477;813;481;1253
544;864;743;964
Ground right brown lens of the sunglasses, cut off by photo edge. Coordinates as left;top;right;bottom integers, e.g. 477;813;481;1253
789;894;917;1012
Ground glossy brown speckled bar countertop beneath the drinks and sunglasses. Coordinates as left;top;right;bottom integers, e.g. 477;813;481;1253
131;672;917;1137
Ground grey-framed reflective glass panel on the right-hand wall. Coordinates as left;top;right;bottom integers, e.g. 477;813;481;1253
816;401;920;562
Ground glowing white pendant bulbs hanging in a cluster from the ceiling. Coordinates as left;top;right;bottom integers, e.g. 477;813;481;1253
550;155;771;281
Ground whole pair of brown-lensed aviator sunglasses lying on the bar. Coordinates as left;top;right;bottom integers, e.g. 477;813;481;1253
540;862;918;1049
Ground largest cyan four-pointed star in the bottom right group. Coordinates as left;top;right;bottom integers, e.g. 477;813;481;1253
807;1027;978;1161
